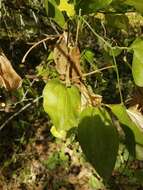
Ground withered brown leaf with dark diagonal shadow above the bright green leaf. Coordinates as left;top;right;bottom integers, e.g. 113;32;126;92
53;32;82;83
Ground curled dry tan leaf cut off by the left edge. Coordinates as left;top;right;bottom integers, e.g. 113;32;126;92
0;49;22;90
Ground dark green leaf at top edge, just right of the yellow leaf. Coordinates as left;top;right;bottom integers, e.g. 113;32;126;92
76;0;112;14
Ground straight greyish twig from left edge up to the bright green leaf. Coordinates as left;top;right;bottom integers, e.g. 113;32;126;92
0;96;43;131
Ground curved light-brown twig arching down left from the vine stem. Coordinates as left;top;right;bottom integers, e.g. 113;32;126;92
22;35;61;63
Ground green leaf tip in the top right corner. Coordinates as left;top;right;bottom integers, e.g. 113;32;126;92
125;0;143;14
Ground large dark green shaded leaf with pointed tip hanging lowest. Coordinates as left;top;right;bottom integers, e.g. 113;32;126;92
78;107;119;180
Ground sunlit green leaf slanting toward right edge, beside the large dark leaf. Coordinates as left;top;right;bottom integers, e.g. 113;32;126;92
110;104;143;145
